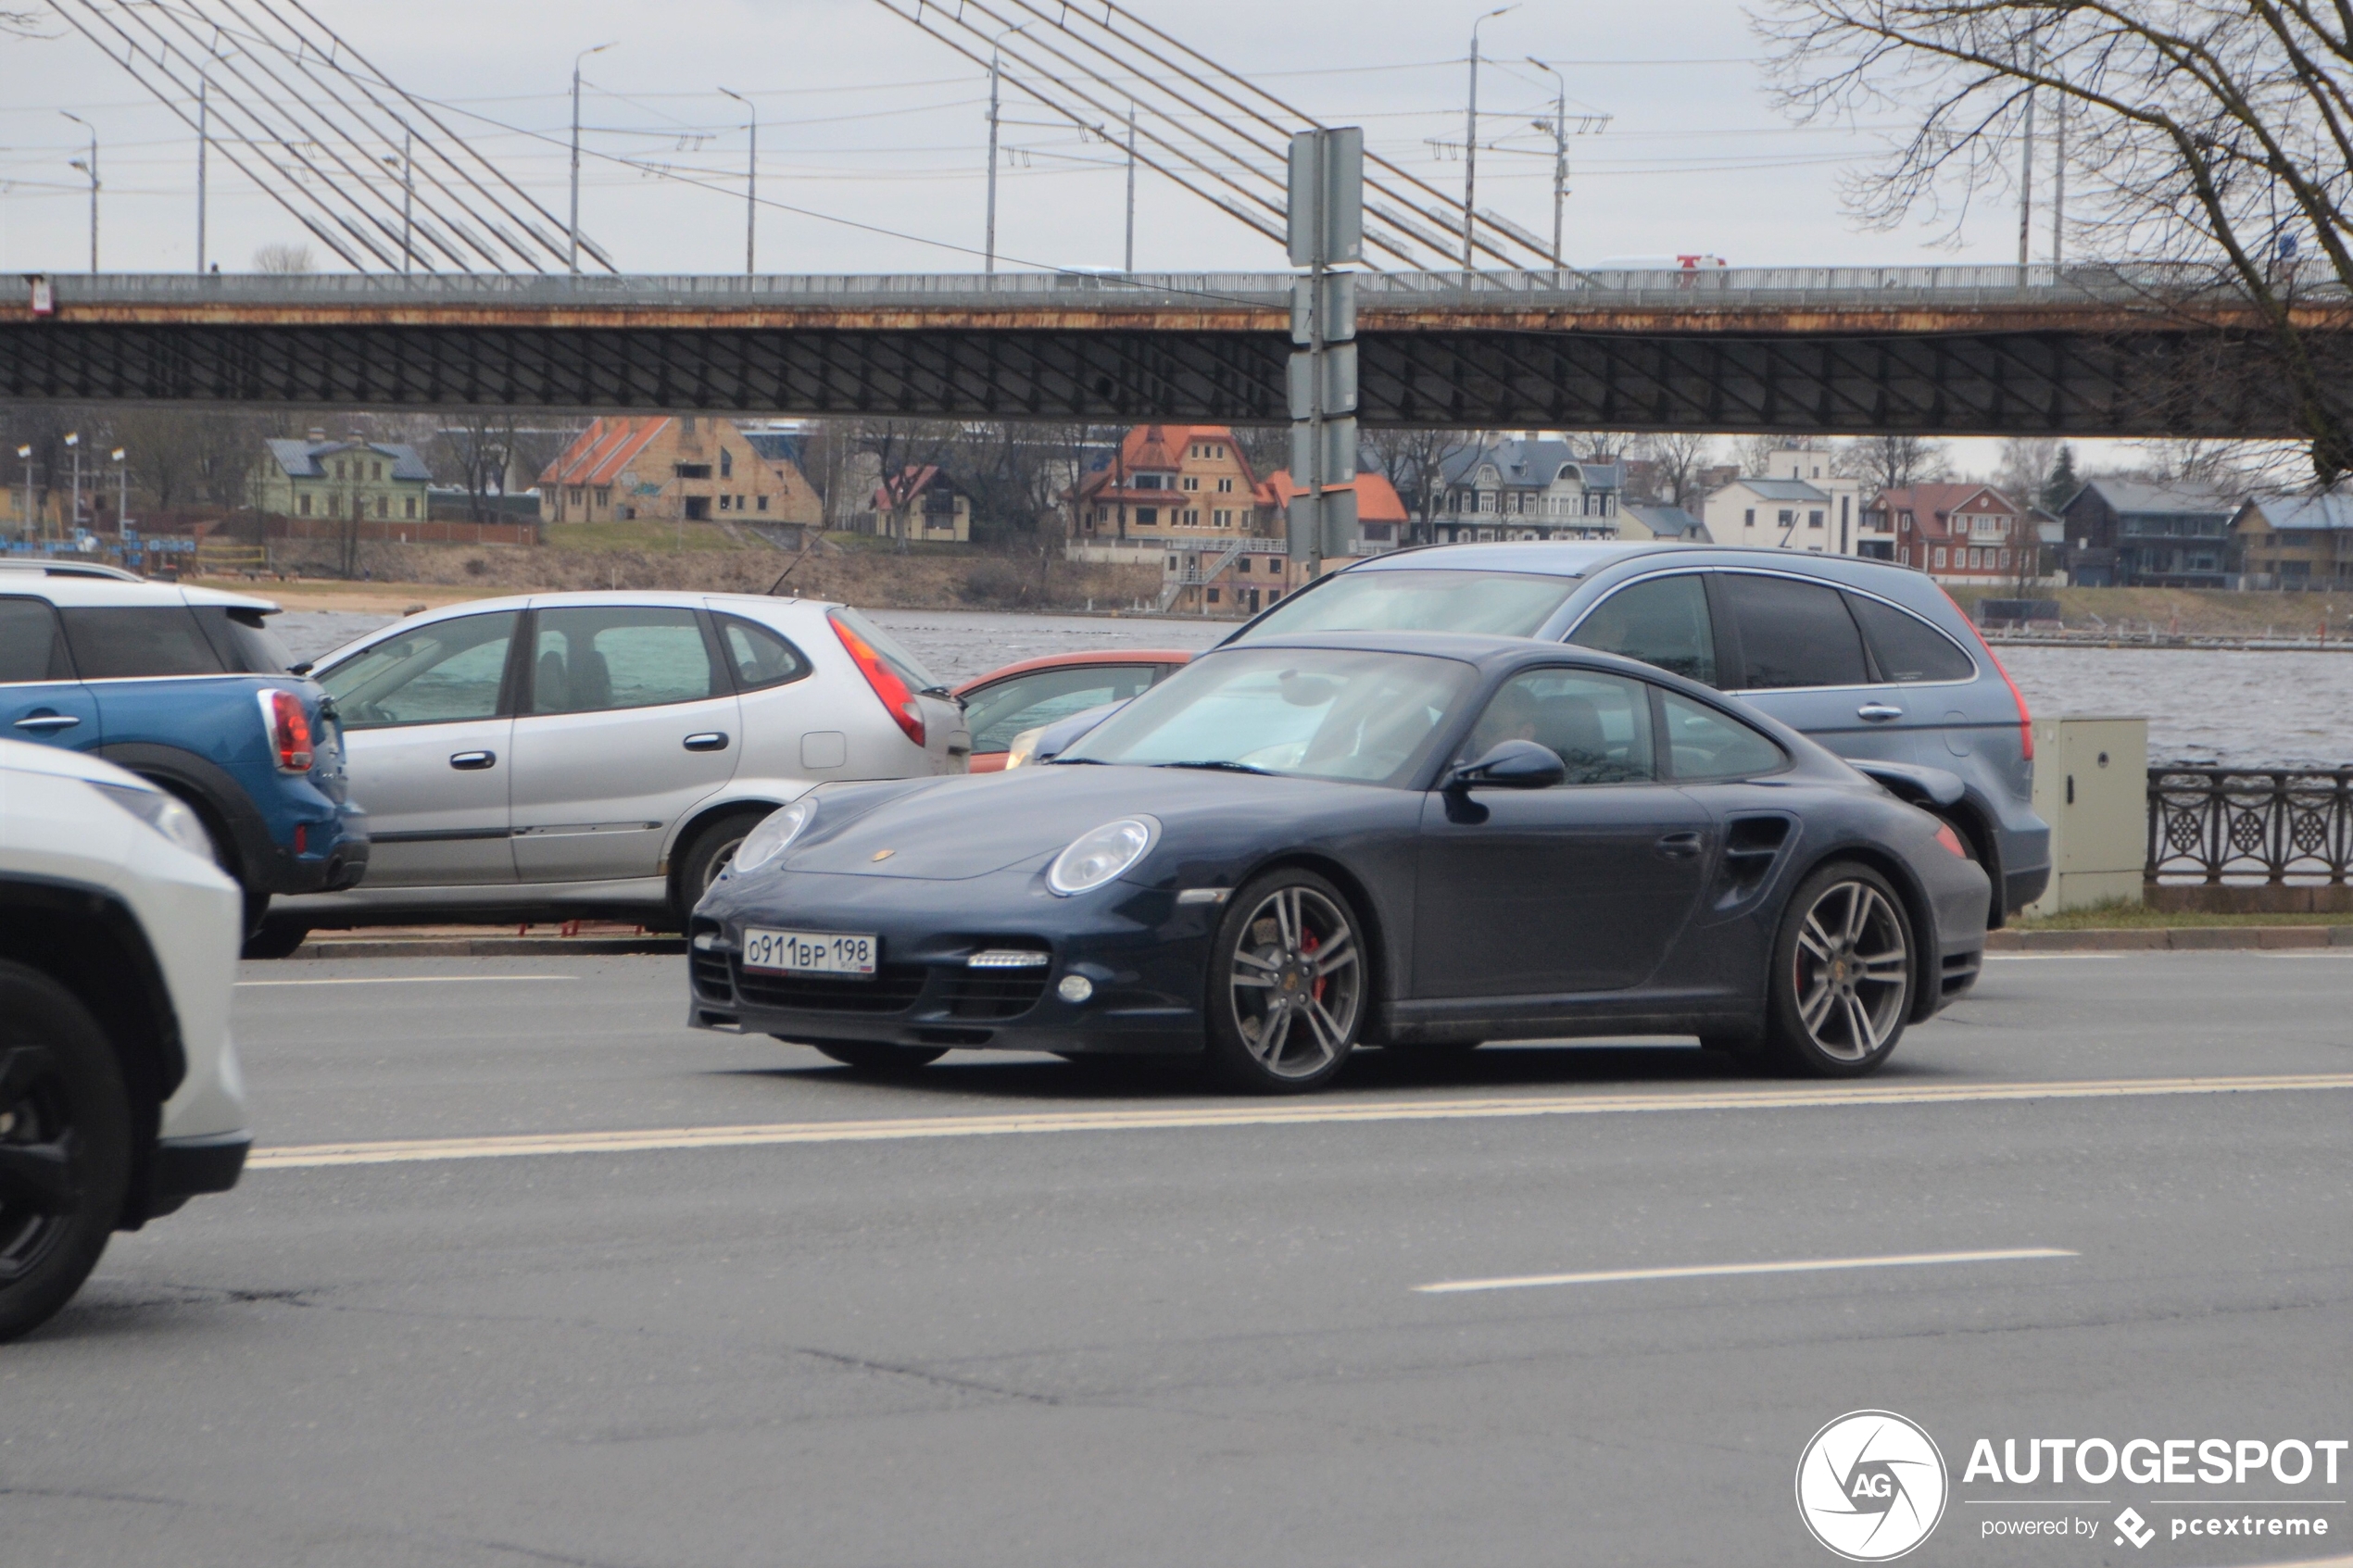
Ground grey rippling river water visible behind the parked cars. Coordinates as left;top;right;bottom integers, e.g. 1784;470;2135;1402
273;608;2353;766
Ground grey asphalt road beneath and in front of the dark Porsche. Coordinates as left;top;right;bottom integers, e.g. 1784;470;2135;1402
0;952;2353;1568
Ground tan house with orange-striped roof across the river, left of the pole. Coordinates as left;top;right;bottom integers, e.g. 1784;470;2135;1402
539;414;824;527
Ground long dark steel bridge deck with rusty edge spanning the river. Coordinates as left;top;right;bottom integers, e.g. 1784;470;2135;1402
0;266;2353;437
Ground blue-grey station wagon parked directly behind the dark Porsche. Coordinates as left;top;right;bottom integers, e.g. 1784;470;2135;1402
1228;541;2049;924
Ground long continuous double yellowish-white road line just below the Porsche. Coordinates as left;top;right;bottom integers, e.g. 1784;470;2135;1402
245;1072;2353;1171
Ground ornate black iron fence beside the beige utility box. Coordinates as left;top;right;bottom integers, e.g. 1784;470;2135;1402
2144;769;2353;884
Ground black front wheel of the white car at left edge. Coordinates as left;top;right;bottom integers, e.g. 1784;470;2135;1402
0;961;132;1340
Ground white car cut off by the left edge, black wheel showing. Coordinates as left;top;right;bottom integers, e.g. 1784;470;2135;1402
0;741;252;1340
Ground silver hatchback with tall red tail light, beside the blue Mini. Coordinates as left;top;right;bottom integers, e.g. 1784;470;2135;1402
271;593;972;935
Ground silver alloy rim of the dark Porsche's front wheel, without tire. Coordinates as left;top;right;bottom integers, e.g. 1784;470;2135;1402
1230;886;1365;1079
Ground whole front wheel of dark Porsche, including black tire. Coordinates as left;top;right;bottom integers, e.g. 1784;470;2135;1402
1202;868;1372;1093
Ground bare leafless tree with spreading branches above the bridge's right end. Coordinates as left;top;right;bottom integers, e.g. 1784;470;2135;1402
1757;0;2353;484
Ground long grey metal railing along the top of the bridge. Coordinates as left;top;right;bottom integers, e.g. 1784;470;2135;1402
36;263;2322;310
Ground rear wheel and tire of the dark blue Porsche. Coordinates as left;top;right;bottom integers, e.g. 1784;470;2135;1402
1765;860;1918;1079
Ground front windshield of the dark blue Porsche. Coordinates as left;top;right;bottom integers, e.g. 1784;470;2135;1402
1059;649;1476;785
